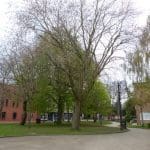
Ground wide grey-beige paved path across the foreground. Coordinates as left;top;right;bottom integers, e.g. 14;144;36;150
0;129;150;150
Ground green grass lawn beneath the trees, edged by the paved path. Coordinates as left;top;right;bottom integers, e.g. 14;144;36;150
0;122;124;137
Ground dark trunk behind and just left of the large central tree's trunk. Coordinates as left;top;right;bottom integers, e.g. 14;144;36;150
57;98;64;125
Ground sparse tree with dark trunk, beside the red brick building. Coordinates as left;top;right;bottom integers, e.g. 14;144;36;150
8;39;37;125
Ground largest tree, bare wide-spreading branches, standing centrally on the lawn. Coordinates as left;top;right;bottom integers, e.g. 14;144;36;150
17;0;133;129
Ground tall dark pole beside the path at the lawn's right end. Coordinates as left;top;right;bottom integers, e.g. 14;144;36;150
118;82;123;130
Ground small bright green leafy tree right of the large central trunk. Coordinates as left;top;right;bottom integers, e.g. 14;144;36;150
82;81;111;121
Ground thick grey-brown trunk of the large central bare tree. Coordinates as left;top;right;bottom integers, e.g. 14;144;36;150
72;100;81;130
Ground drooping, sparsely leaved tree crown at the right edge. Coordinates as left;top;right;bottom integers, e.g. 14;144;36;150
125;17;150;83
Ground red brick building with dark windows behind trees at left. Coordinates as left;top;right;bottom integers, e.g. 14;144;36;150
0;85;37;123
